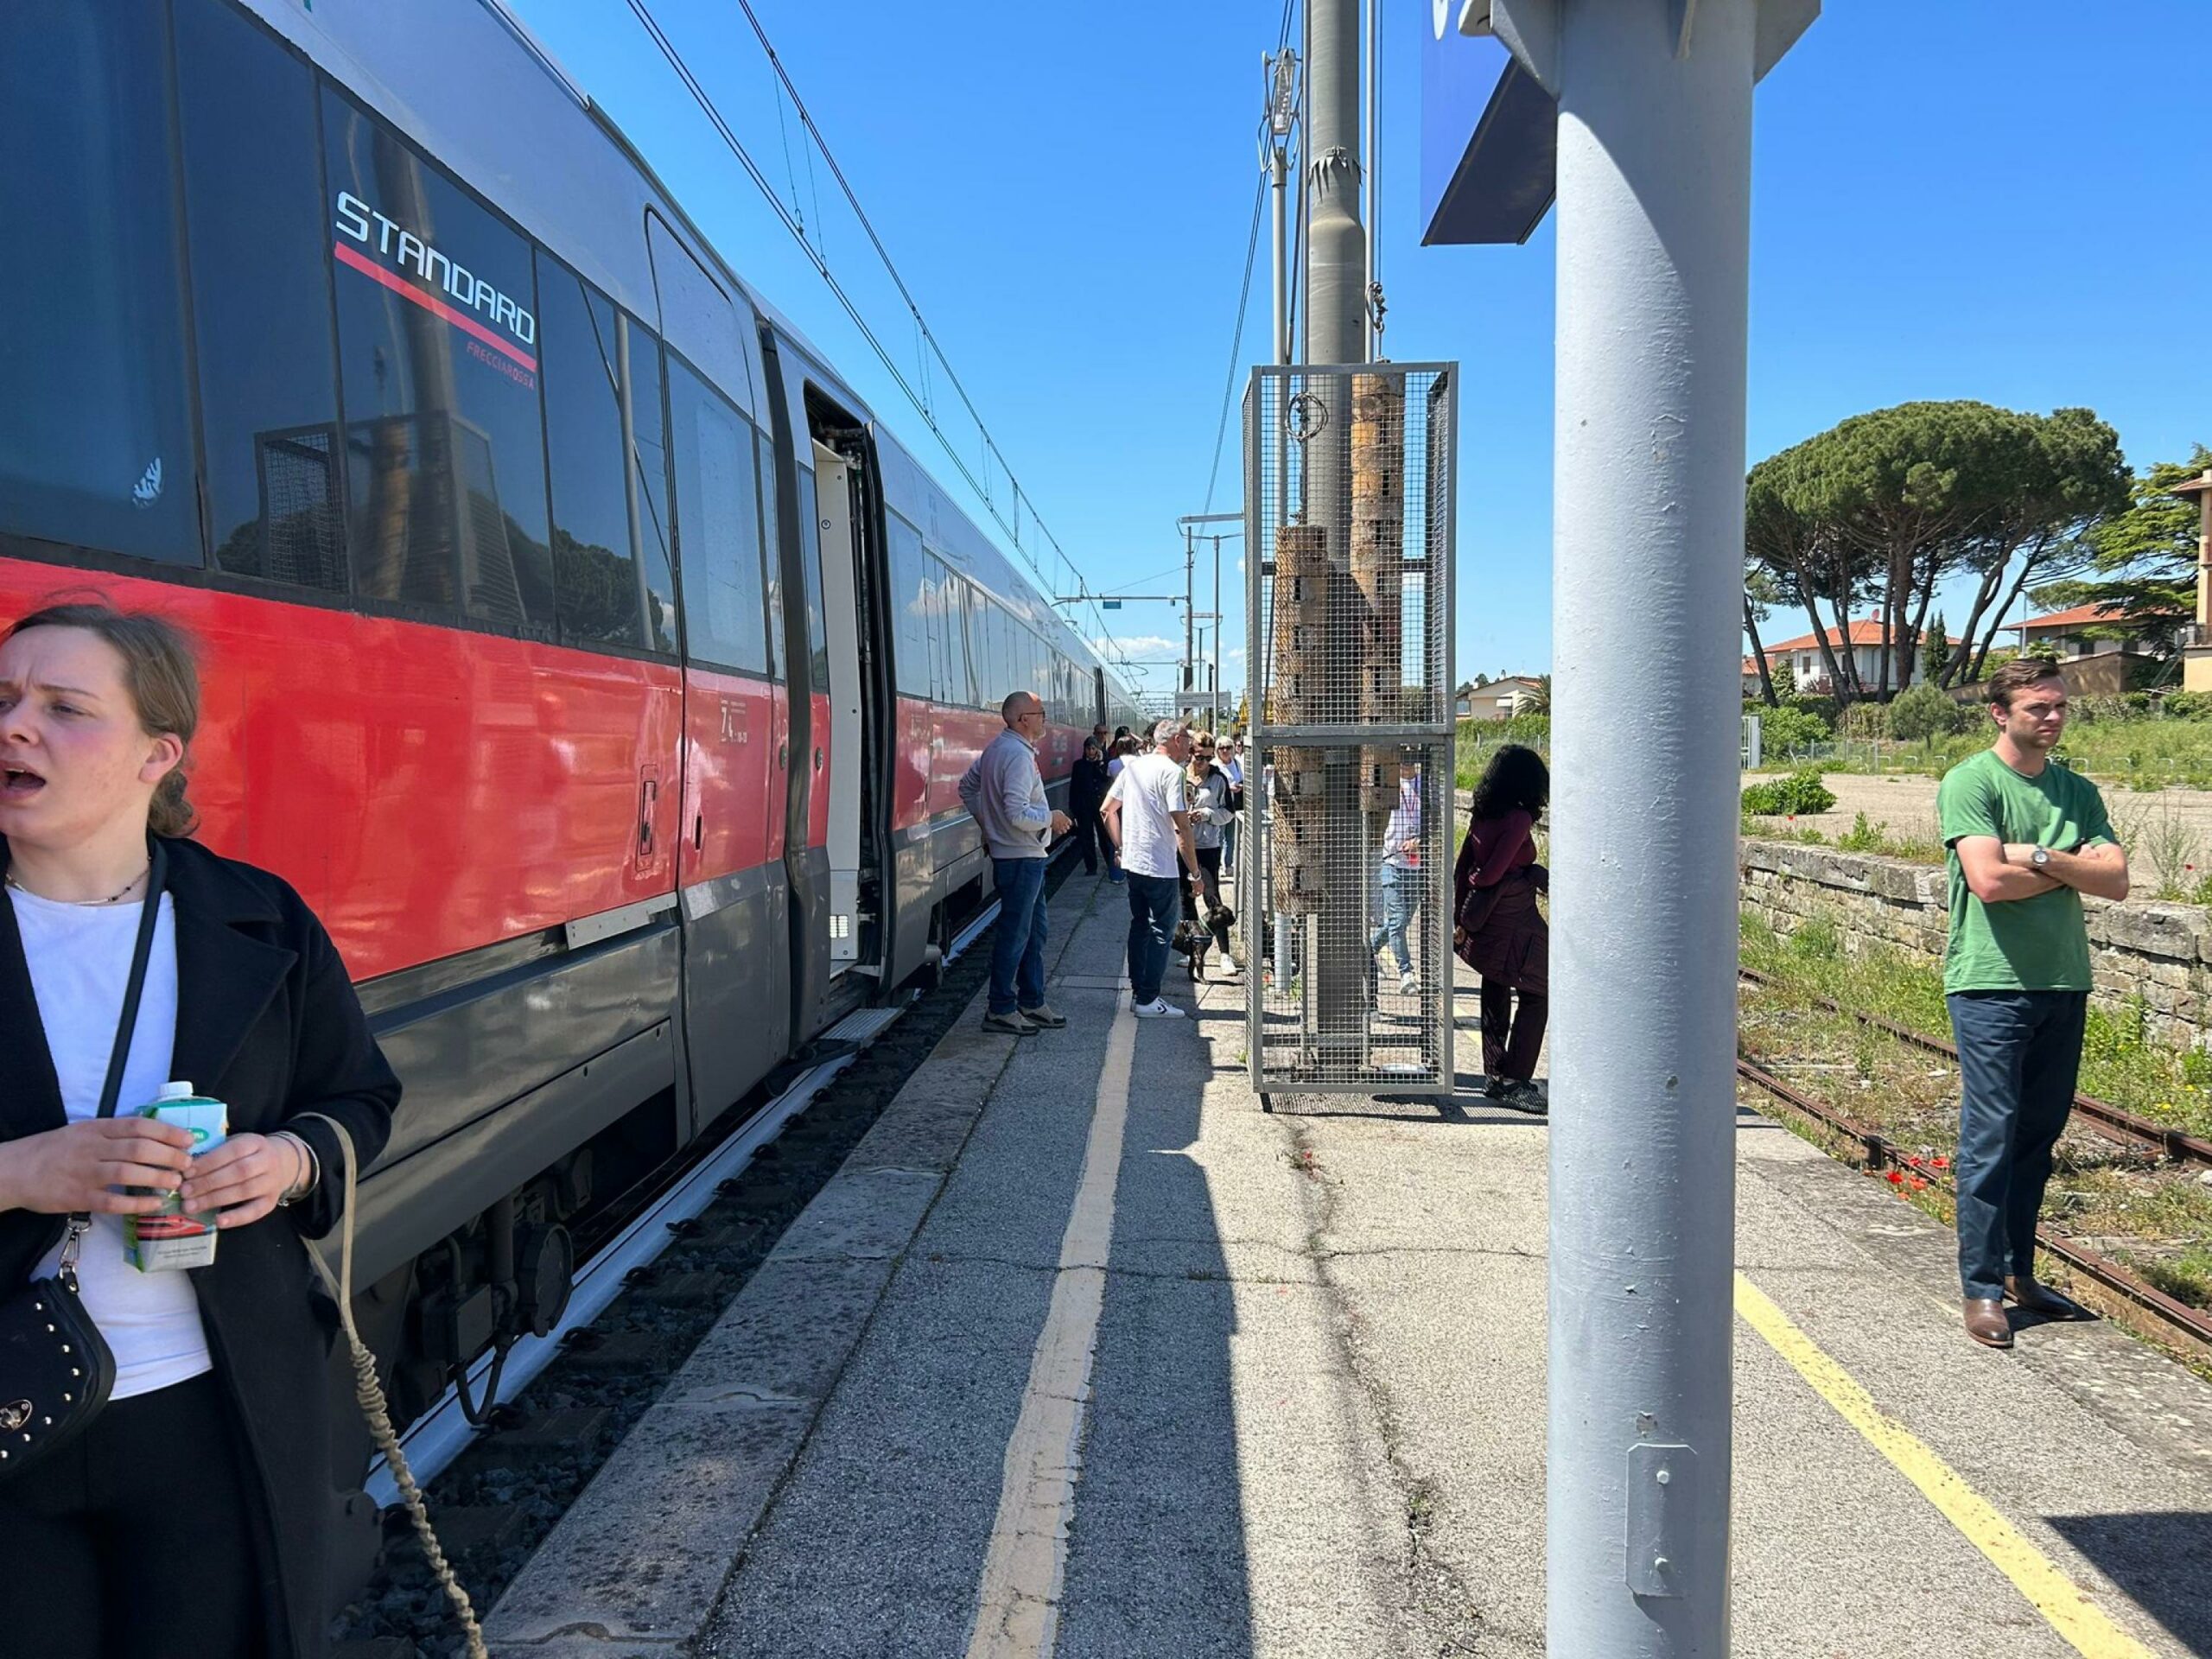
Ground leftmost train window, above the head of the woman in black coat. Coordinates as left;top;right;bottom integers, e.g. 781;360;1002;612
0;0;201;564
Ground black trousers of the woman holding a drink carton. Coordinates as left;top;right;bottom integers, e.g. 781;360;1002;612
0;1374;265;1659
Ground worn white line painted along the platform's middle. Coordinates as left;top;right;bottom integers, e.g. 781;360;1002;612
969;991;1137;1659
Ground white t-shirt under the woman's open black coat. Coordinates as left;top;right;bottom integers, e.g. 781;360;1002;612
9;887;213;1400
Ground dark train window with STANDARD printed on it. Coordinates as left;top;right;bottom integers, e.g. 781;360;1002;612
323;88;553;637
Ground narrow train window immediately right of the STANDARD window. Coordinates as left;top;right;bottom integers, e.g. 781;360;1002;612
537;254;646;646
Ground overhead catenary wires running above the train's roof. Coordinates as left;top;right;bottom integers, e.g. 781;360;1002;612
628;0;1113;664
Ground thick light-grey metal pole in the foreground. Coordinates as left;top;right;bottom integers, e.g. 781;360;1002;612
1539;0;1758;1659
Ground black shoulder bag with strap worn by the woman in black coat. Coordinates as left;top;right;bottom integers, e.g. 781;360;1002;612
0;836;168;1484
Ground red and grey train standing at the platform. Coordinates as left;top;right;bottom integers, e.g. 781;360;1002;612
0;0;1135;1583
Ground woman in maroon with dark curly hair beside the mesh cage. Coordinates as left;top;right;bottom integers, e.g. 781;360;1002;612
1451;743;1551;1113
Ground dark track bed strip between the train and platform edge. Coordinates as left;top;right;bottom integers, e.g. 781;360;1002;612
334;858;1068;1659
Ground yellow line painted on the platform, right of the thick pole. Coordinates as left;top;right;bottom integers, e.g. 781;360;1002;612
1737;1272;2157;1659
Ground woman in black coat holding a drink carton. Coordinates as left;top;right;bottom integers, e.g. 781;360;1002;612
0;606;400;1659
